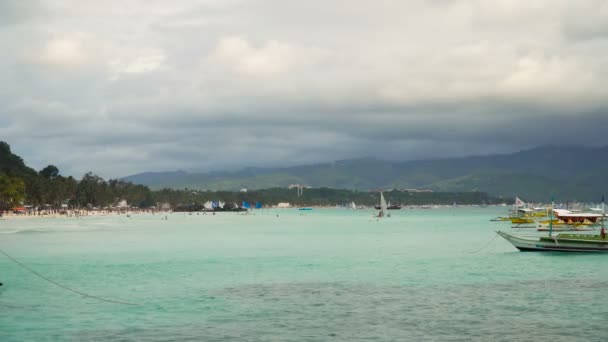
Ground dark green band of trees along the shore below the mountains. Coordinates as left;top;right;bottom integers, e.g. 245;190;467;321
0;141;504;210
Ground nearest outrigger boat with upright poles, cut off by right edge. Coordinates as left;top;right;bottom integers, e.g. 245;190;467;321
496;198;608;252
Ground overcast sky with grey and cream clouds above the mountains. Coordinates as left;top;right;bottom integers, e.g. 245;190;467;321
0;0;608;178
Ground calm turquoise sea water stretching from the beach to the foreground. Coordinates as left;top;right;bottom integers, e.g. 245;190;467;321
0;208;608;341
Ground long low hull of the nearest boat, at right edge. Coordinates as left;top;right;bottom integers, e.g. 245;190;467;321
496;231;608;253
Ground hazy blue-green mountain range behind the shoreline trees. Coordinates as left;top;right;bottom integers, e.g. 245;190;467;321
123;146;608;202
